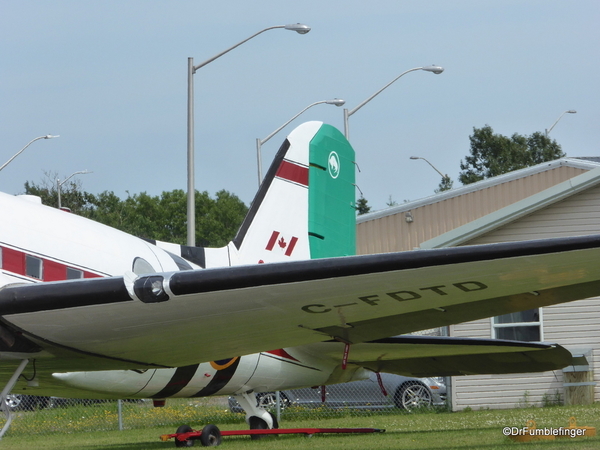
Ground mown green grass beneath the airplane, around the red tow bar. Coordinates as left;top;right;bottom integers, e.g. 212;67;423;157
0;404;600;450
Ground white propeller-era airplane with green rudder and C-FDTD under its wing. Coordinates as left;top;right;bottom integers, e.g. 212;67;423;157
0;121;600;437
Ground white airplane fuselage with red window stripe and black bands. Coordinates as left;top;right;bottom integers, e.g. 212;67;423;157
0;193;369;398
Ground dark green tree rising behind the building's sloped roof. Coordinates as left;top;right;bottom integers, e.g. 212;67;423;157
458;125;566;184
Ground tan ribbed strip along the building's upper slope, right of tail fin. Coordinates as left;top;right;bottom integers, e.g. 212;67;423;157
356;166;586;255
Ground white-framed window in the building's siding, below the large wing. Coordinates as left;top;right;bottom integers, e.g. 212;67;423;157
492;308;542;342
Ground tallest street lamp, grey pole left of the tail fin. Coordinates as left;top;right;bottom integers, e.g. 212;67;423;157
187;23;310;247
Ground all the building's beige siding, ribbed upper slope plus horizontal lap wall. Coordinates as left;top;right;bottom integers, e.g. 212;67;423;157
357;162;600;410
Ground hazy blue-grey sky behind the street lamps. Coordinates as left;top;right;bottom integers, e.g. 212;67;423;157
0;0;600;210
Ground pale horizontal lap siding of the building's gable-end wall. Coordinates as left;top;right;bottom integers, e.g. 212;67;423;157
450;187;600;410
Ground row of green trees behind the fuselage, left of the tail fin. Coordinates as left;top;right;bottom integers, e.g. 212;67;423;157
25;182;248;247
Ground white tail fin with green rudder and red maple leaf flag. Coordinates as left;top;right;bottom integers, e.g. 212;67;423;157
229;122;356;265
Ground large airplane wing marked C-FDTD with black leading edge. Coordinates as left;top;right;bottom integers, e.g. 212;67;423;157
0;236;600;371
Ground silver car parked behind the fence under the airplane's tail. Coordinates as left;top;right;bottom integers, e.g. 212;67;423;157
229;373;446;412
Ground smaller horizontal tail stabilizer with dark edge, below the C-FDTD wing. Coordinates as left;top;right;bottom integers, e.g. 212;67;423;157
300;336;573;378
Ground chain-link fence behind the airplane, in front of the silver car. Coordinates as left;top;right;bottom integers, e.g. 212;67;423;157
0;374;445;435
